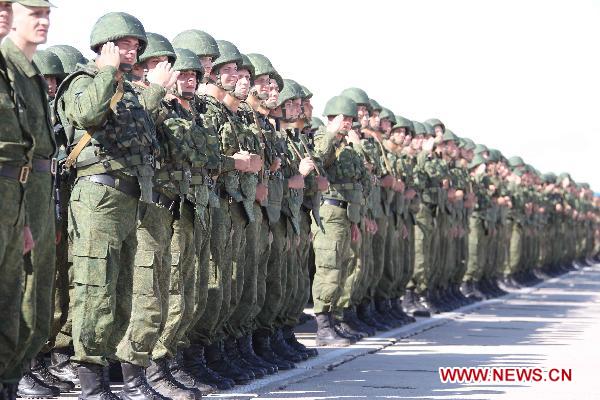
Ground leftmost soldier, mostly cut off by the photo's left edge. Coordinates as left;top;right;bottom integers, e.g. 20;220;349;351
0;0;33;400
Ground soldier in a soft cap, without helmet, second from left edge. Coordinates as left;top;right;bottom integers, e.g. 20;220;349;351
2;0;59;397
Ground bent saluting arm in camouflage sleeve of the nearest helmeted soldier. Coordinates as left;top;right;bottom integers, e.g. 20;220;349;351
63;66;117;129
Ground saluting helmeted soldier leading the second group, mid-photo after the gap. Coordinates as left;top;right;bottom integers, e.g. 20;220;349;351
312;96;369;346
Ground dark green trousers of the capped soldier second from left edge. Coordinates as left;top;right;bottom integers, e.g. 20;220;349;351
3;173;56;380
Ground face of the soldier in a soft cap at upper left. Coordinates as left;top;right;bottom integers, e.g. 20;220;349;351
12;3;50;45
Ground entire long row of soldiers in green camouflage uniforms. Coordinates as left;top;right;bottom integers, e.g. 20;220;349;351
0;0;600;400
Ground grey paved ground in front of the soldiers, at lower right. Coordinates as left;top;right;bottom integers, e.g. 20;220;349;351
217;265;600;400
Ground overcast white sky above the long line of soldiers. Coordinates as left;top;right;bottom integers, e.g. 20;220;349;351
39;0;600;191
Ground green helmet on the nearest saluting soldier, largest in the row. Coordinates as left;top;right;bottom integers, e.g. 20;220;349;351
90;12;148;57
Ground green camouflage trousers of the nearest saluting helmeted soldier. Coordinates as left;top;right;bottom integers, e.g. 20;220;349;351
69;180;138;365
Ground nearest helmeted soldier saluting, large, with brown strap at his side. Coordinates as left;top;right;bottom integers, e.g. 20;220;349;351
57;13;174;399
